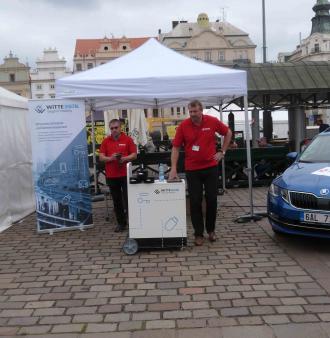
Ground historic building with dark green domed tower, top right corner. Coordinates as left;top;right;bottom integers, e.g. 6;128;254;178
278;0;330;62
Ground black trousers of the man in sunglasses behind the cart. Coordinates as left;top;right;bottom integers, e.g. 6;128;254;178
107;176;128;226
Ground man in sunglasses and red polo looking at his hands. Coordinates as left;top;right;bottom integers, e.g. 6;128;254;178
100;119;137;232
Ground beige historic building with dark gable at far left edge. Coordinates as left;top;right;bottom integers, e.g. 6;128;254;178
0;52;31;99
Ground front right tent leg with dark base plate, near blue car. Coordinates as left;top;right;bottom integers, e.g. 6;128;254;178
235;96;265;223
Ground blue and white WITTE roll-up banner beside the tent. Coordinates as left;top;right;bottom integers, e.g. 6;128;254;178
29;99;93;233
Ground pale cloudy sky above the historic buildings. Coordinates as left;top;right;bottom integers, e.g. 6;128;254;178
0;0;316;68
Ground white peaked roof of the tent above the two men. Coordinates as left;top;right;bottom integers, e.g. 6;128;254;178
56;39;247;108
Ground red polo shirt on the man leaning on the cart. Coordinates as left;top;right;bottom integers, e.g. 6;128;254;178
172;115;228;171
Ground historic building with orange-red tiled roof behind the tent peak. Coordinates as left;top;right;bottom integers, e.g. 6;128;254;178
73;36;149;73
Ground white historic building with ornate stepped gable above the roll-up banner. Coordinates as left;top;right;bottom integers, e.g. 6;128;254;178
30;48;72;99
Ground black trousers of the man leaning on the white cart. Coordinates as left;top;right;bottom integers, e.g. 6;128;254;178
186;166;218;236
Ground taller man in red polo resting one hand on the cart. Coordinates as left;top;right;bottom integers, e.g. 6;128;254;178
169;100;232;246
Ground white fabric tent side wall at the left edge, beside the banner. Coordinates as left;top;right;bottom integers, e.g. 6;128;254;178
0;87;35;232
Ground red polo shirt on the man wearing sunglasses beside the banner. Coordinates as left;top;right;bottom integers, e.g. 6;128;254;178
100;133;137;178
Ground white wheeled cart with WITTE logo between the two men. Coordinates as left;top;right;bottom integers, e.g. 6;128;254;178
123;163;187;255
